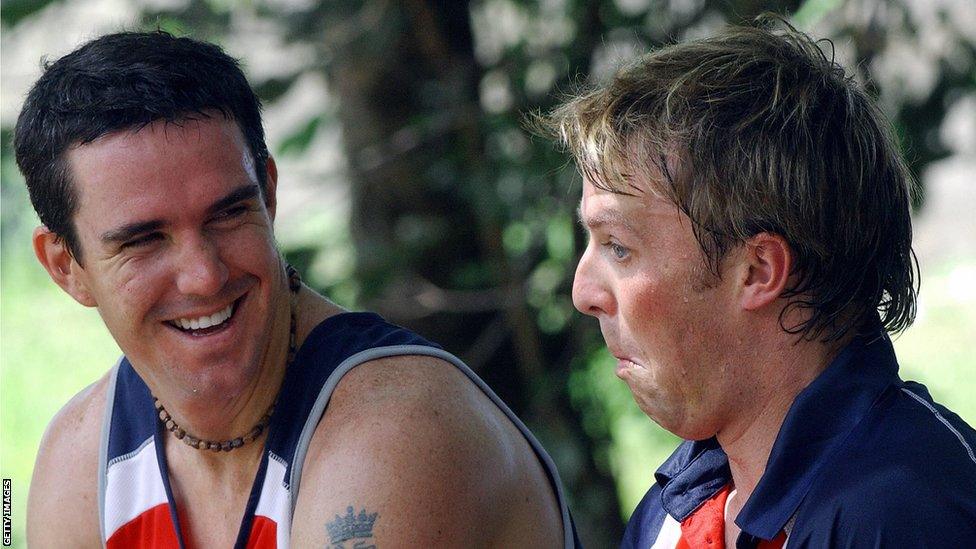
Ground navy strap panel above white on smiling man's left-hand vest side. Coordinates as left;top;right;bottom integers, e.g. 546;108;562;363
108;358;156;462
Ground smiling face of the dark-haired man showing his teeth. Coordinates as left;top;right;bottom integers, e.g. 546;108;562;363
42;116;289;399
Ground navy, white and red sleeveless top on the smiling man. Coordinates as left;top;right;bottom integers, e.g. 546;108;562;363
98;313;579;549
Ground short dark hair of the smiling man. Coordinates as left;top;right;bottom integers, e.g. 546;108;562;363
14;31;268;261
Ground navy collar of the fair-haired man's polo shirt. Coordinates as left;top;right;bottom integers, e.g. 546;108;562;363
655;332;900;539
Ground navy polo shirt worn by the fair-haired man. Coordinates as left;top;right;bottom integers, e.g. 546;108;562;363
621;333;976;549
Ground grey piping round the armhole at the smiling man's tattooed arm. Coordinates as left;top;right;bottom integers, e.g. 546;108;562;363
289;345;575;548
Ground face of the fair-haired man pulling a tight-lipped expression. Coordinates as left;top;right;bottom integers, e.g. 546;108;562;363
573;181;742;439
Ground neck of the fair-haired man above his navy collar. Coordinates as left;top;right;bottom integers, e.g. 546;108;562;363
716;333;840;503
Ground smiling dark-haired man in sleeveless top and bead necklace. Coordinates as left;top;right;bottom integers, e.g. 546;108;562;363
15;32;574;548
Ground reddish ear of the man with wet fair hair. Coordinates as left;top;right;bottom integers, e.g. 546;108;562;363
741;233;793;311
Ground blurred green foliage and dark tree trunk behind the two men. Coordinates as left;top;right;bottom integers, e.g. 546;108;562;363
0;0;976;546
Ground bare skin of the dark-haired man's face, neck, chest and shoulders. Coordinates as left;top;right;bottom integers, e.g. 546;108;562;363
27;114;562;547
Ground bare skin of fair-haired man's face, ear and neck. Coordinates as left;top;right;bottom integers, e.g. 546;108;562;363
573;176;846;546
